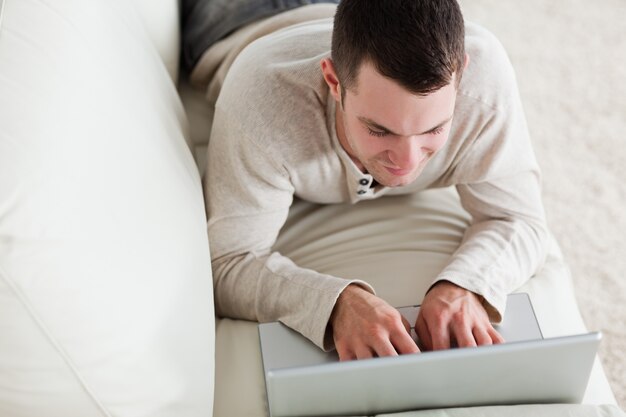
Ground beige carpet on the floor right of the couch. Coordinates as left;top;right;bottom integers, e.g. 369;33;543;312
460;0;626;408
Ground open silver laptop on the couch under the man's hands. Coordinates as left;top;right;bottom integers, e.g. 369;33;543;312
259;294;601;417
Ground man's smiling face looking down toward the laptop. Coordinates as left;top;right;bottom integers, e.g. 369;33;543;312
331;63;456;187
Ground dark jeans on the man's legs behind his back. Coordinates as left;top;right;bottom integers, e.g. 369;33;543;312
181;0;340;71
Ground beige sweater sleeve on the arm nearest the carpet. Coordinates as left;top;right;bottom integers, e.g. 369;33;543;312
437;82;548;322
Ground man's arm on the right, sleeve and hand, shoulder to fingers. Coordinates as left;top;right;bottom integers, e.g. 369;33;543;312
417;68;547;348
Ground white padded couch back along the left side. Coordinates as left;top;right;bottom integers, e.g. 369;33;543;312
0;0;214;417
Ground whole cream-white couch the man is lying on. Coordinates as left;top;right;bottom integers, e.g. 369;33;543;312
0;0;623;417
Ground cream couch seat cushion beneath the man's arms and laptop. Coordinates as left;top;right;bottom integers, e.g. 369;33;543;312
215;189;618;417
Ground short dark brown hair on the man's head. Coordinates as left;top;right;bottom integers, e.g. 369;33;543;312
331;0;465;95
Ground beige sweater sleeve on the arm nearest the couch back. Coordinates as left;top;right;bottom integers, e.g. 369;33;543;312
204;107;374;350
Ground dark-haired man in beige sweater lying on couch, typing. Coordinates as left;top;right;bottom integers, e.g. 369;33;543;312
183;0;546;360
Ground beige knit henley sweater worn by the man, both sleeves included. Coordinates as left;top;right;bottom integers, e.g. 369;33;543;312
204;19;547;349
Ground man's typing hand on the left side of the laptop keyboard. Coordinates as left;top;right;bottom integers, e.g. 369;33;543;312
330;284;420;361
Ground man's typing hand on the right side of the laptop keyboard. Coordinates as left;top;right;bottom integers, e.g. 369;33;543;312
415;281;504;350
